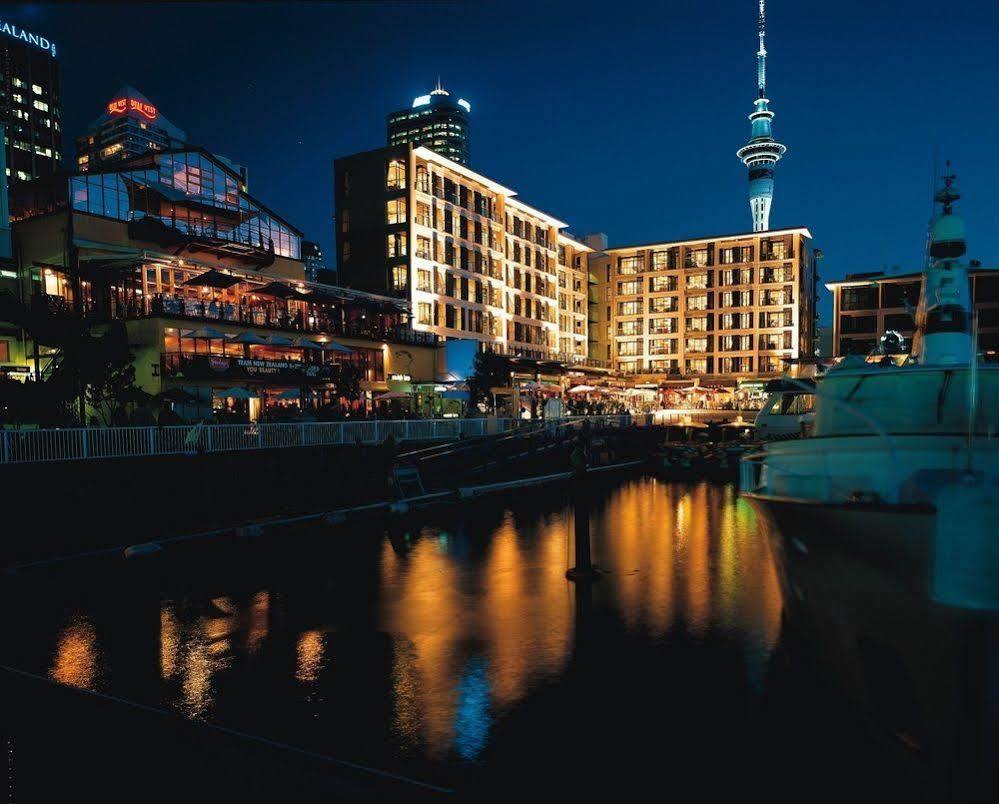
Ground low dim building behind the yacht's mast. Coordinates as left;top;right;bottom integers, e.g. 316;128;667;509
826;268;999;360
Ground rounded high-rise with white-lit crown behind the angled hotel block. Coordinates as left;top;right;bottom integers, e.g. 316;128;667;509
388;79;472;165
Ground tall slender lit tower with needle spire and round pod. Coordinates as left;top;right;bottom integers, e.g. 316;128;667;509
736;0;787;232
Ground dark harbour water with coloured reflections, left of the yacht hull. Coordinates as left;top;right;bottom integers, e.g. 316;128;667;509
2;478;984;801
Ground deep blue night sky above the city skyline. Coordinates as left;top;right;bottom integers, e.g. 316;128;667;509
9;0;999;318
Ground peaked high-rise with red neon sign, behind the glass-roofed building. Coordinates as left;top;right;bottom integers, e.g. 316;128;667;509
76;86;248;191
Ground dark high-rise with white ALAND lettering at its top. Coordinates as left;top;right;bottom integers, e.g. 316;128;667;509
0;20;62;186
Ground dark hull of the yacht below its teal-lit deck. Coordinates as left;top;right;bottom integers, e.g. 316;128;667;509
745;494;999;800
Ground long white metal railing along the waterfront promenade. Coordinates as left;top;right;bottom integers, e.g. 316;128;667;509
0;415;632;463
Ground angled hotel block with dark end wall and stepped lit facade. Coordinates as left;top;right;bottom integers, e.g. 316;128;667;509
334;145;593;363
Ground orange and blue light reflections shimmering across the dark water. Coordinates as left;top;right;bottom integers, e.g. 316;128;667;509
37;479;781;761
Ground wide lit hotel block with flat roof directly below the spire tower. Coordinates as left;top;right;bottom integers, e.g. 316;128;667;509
590;223;816;382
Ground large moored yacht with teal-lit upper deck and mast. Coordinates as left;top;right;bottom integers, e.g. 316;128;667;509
740;176;999;792
